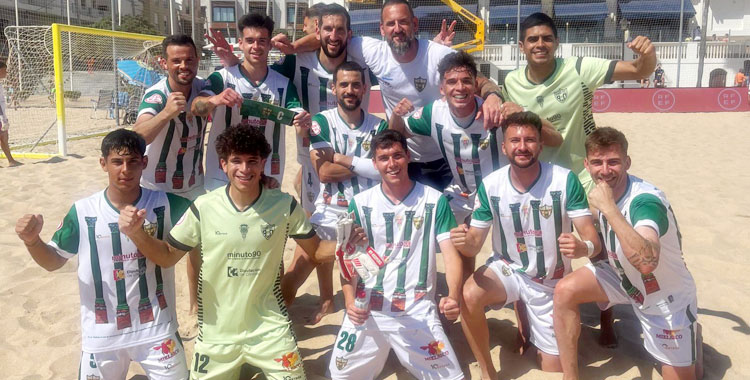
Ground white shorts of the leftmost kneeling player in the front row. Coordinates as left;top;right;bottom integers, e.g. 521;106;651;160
78;333;189;380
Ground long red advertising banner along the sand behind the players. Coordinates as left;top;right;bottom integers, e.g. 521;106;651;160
369;87;750;113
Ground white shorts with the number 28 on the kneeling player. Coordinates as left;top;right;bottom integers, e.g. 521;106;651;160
328;312;464;380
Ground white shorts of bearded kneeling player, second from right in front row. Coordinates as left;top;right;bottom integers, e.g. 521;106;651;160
485;257;560;355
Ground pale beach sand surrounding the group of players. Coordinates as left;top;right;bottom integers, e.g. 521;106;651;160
0;113;750;379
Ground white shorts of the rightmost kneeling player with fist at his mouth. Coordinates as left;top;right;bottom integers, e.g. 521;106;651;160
586;261;698;367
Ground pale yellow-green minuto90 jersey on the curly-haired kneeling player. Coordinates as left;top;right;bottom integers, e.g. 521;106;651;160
167;186;315;344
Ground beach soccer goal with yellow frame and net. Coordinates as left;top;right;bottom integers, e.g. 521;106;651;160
3;24;164;155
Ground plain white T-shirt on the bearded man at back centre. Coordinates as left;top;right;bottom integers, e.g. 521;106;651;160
347;37;455;162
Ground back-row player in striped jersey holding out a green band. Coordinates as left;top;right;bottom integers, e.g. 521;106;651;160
190;13;310;191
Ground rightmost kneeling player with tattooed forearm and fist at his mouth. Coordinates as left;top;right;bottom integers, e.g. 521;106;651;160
554;127;702;380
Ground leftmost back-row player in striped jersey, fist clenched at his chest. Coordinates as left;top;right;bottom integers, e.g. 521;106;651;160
133;34;207;324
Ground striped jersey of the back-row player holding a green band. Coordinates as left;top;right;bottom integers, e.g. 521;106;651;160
201;65;302;191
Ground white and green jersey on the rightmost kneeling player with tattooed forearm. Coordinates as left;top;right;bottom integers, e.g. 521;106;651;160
599;175;696;316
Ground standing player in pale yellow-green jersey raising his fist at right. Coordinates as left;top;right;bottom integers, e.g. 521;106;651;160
503;13;656;190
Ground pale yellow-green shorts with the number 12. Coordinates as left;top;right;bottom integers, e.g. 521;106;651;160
190;330;306;380
